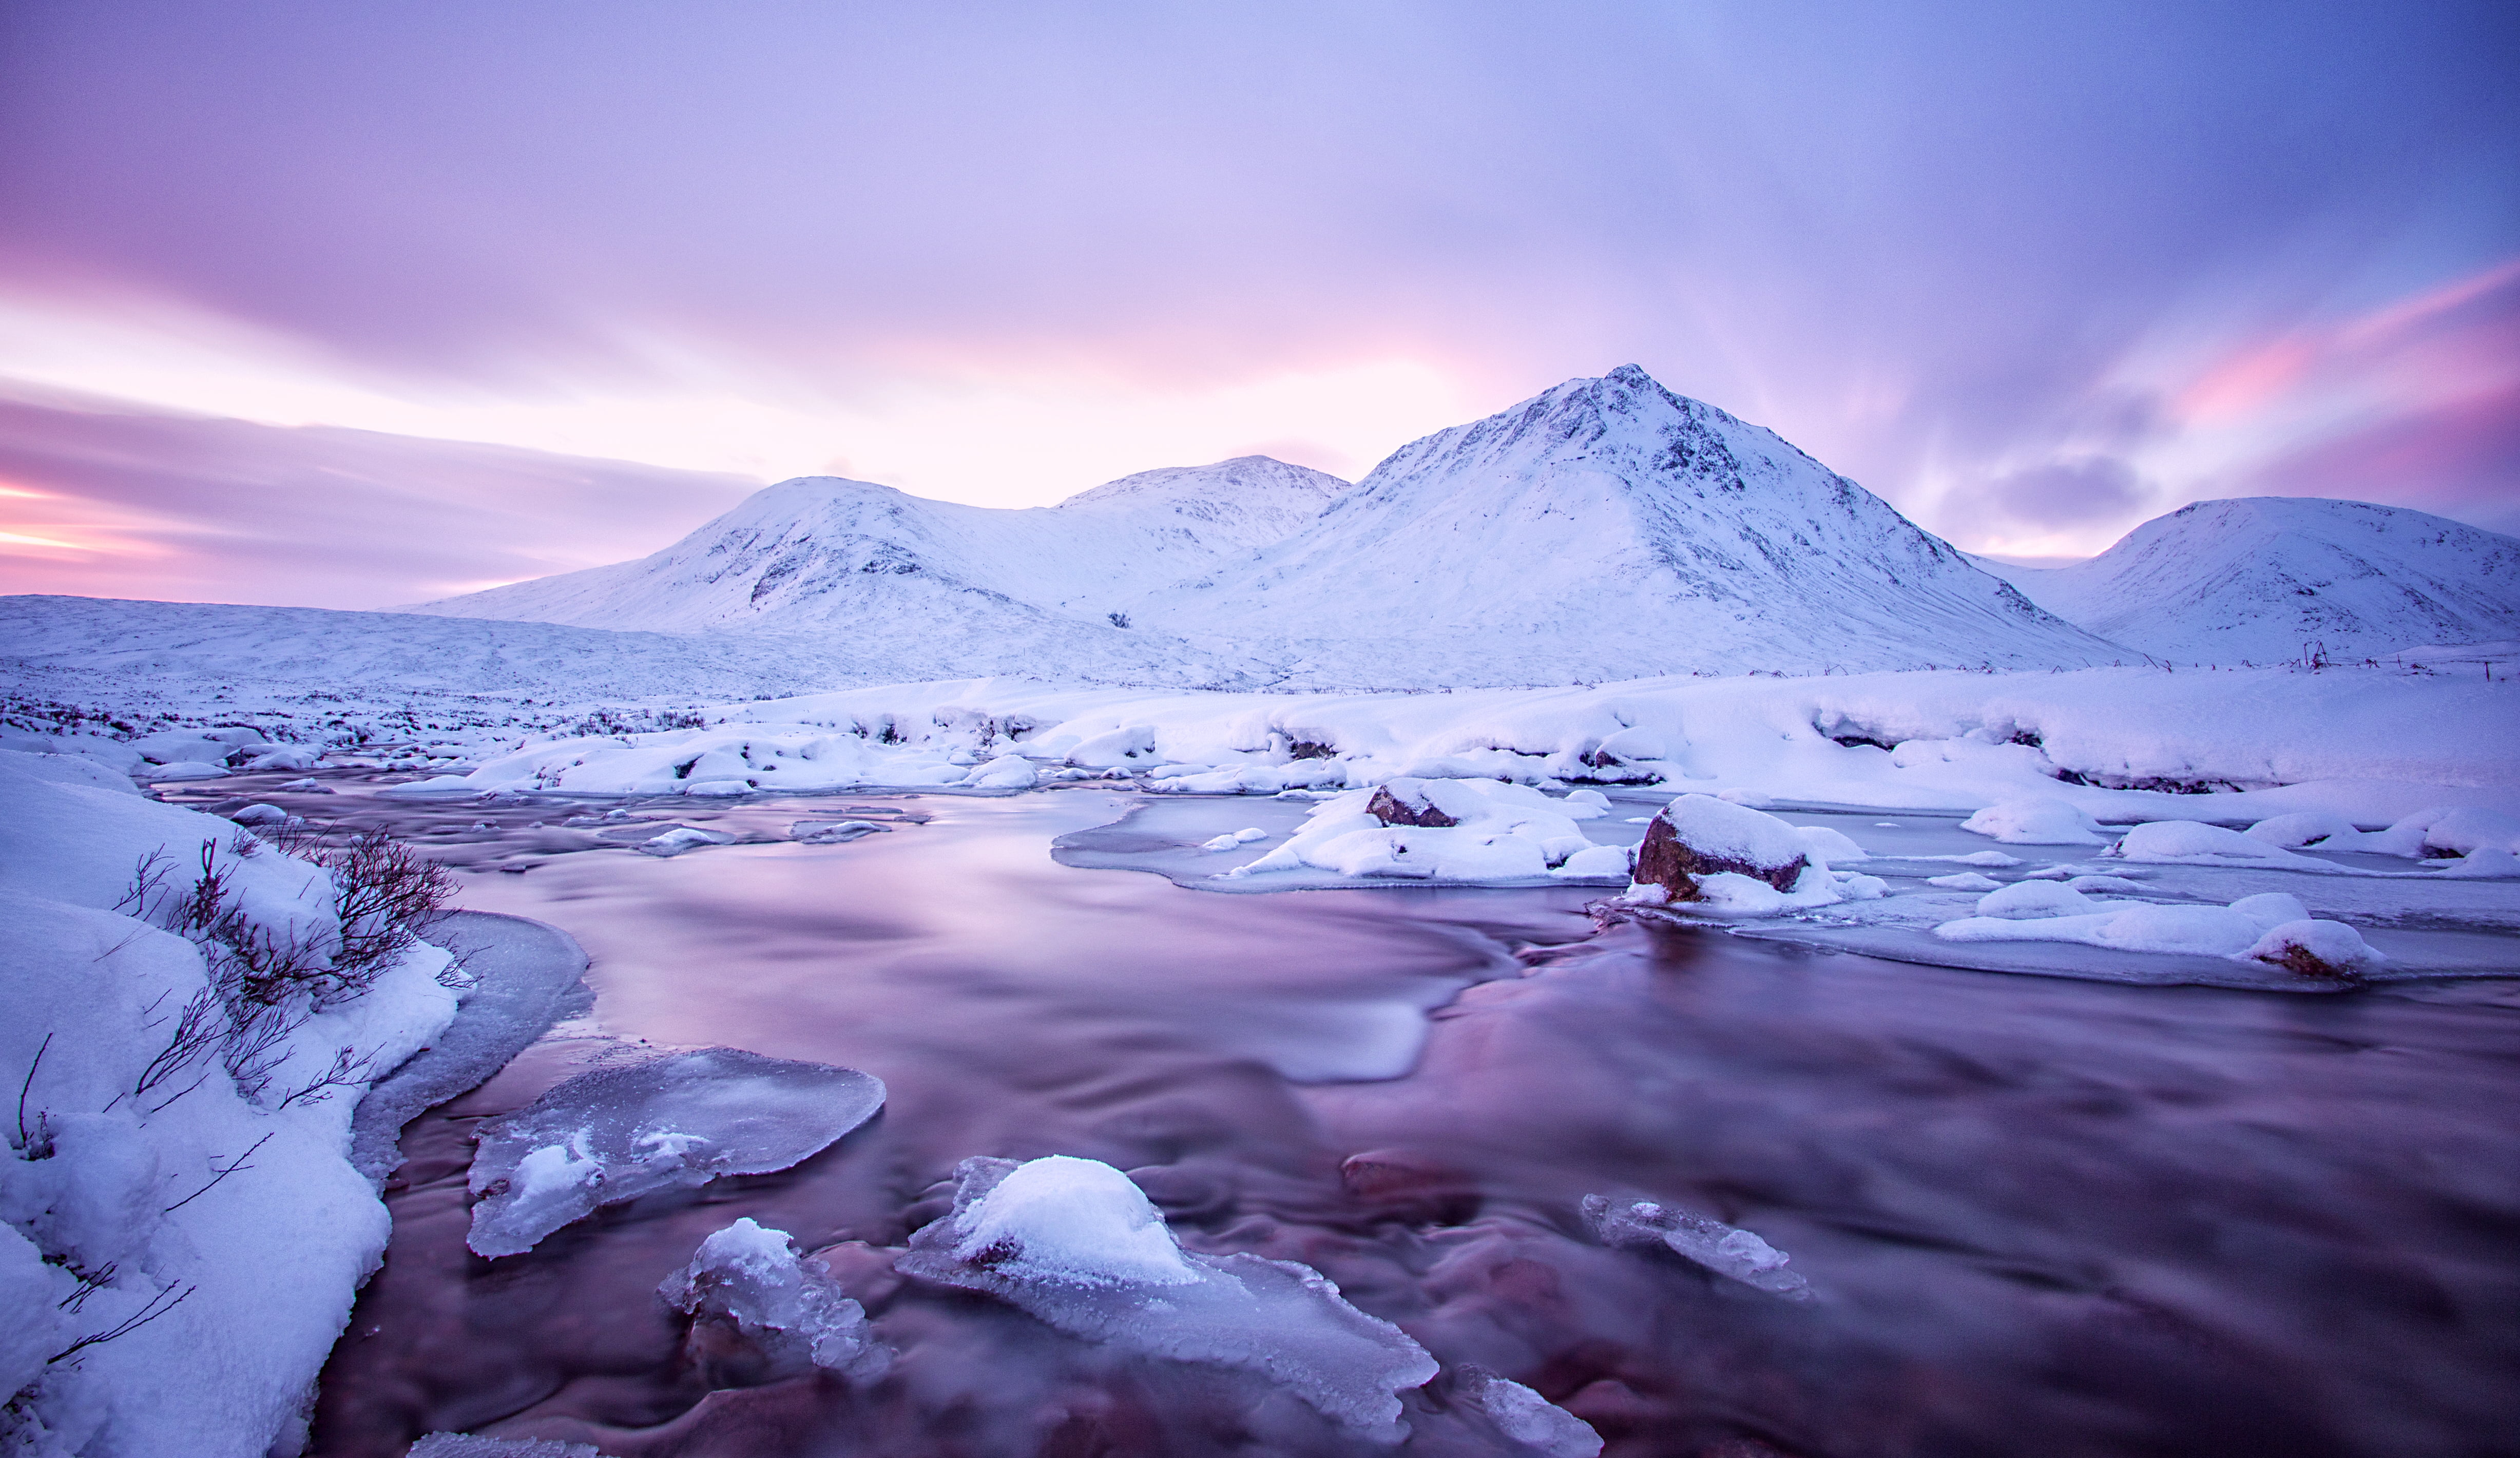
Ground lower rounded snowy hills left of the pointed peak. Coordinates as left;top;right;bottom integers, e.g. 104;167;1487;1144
413;456;1348;637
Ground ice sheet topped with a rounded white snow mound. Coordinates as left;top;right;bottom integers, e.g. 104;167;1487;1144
892;1156;1436;1443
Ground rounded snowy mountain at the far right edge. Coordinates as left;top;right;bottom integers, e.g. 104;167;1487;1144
1986;496;2520;662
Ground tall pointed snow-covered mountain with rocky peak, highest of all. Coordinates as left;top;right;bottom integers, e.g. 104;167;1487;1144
1131;365;2127;687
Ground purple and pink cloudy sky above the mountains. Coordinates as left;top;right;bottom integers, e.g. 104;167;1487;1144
0;0;2520;607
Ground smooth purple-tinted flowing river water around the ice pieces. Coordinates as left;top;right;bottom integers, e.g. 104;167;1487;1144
281;791;2520;1458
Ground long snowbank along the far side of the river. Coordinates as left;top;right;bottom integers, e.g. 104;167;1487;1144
416;667;2520;834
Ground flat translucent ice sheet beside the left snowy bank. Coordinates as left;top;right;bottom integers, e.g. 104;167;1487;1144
464;1047;884;1257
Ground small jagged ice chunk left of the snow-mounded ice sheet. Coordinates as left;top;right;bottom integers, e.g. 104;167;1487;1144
655;1219;892;1383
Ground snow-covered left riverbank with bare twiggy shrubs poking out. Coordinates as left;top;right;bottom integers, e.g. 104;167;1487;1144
0;753;458;1458
